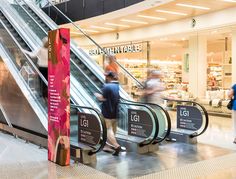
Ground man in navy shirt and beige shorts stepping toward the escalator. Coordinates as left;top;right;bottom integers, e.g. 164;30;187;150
94;71;121;156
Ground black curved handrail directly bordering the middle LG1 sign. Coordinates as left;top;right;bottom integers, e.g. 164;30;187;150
119;101;159;147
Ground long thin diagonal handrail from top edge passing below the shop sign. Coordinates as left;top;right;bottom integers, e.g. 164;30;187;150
41;0;144;88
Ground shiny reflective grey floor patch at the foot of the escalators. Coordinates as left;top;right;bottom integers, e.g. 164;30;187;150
91;143;232;178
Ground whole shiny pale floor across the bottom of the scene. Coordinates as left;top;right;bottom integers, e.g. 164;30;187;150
0;116;236;179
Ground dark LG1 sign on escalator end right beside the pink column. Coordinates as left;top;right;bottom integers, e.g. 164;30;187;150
78;113;101;146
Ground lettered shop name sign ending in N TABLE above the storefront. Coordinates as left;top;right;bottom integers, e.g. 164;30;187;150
89;44;142;55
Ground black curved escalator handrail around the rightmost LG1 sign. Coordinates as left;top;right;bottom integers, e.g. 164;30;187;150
163;98;209;138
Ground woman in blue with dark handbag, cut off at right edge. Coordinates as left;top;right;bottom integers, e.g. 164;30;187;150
229;84;236;144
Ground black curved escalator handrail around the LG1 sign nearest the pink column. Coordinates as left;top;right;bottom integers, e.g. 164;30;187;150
70;104;107;155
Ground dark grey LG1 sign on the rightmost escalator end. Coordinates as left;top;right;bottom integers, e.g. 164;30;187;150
177;105;202;131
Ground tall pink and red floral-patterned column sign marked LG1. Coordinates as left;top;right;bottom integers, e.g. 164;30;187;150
48;28;70;166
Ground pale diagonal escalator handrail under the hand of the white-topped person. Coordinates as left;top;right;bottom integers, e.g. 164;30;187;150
2;11;48;86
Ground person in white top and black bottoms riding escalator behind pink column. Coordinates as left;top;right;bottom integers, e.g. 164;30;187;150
22;37;48;101
